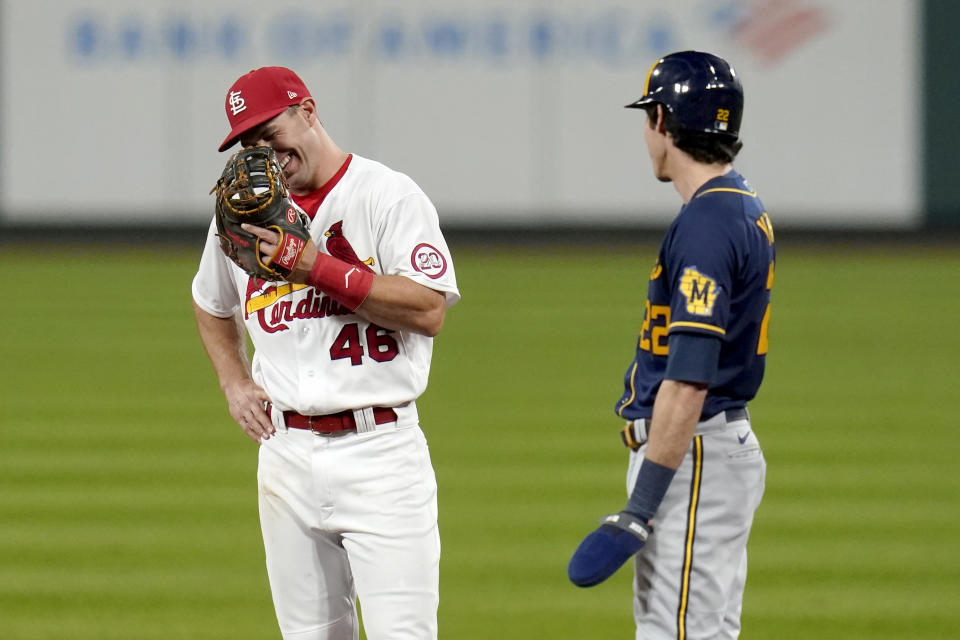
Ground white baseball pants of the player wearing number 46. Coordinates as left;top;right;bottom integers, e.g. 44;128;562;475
257;425;440;640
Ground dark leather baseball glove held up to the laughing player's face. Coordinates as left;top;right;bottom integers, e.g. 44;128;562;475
210;146;310;280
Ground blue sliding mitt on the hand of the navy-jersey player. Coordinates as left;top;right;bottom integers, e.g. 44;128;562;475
567;511;653;587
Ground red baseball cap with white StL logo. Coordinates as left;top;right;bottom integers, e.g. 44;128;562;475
219;67;311;151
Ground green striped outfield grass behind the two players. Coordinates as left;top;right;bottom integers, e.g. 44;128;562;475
0;242;960;640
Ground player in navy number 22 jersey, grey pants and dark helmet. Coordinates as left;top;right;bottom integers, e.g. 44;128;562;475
568;51;775;640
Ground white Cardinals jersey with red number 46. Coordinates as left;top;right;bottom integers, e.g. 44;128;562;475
193;155;460;415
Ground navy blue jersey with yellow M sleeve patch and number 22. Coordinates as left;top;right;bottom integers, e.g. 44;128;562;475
616;171;776;420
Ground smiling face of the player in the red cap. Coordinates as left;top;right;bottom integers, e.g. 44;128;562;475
240;100;317;195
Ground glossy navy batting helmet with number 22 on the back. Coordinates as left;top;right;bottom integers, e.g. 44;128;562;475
627;51;743;138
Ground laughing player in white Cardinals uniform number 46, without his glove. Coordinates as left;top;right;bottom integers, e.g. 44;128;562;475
193;67;460;640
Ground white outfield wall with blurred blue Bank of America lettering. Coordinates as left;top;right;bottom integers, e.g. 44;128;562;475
0;0;944;229
